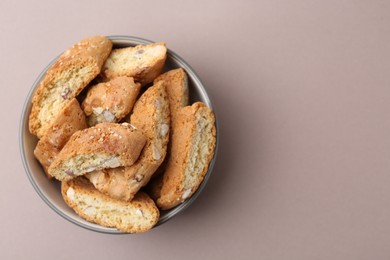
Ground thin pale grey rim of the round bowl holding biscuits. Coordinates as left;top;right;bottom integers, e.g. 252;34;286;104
19;35;219;234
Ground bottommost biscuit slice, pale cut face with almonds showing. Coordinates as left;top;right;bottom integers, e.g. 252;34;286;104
61;177;160;233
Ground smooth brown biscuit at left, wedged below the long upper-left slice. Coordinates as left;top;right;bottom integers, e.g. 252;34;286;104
34;98;87;178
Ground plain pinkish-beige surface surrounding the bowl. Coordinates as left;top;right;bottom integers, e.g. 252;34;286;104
0;0;390;260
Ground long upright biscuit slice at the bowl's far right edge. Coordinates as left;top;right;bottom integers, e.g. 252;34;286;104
157;102;216;210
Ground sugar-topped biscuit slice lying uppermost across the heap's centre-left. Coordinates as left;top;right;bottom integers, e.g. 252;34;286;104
48;123;146;181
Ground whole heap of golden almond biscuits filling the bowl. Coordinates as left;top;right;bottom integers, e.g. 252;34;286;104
29;36;216;233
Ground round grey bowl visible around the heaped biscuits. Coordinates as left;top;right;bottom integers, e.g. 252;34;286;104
19;36;218;234
